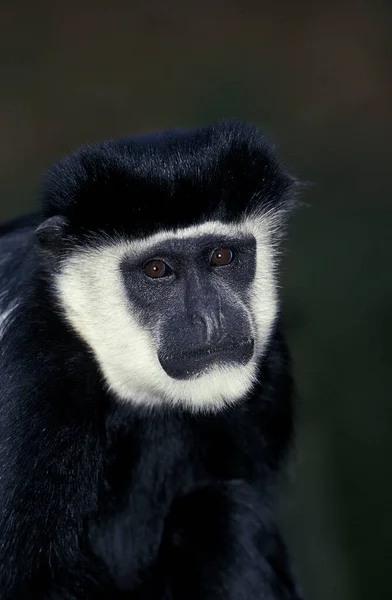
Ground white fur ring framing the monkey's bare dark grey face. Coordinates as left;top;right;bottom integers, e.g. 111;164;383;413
56;216;277;410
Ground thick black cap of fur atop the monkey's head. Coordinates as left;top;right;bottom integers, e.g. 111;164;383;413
43;122;296;235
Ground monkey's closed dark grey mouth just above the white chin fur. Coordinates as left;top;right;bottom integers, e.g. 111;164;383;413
158;338;254;379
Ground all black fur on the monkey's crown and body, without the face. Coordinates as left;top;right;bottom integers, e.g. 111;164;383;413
0;124;299;600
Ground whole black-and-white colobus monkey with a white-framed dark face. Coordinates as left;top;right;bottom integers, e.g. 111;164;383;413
0;123;299;600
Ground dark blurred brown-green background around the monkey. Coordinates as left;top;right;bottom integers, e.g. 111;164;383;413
0;0;392;600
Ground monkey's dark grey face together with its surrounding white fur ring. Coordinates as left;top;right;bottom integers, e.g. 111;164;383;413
57;219;277;408
